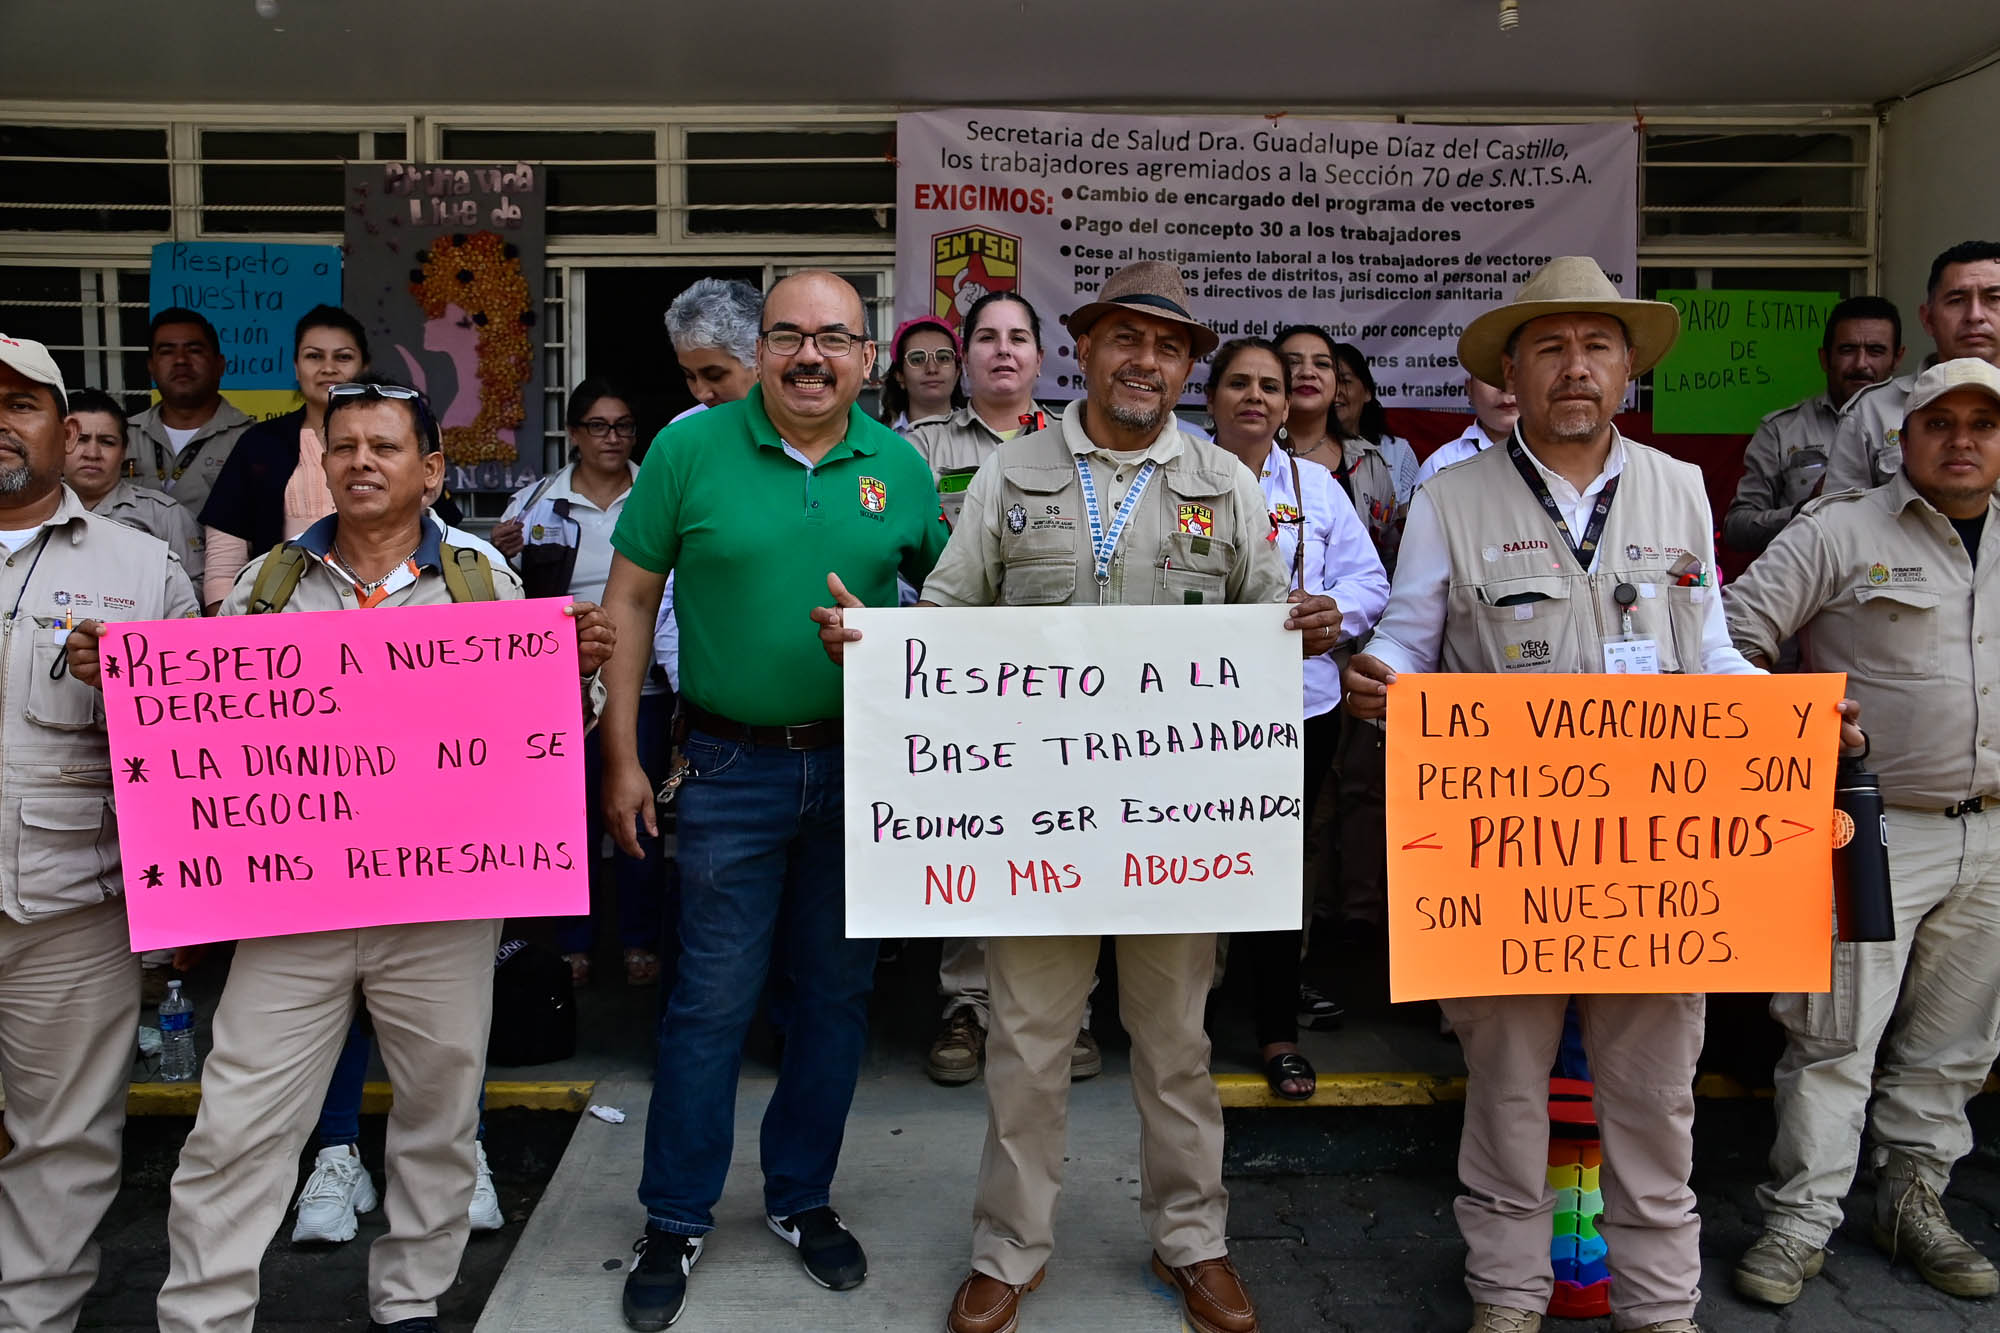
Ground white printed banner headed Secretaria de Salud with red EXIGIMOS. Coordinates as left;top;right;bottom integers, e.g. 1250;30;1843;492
896;110;1638;408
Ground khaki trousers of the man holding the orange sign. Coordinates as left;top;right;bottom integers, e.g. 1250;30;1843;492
1444;995;1708;1329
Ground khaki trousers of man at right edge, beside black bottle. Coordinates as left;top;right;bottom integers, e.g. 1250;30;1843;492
1758;809;2000;1245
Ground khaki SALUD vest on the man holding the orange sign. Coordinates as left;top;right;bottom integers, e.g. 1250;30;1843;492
1424;440;1716;673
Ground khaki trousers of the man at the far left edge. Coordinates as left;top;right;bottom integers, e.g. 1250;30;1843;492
0;901;138;1333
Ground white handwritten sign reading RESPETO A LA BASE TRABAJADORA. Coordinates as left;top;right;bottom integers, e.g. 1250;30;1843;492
844;604;1304;939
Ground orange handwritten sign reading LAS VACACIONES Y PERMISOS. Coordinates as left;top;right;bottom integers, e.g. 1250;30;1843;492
1388;675;1846;1001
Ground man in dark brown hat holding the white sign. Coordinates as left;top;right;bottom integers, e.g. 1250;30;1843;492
814;262;1340;1333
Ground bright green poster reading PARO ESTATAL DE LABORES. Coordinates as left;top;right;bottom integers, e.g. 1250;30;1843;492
1652;290;1840;434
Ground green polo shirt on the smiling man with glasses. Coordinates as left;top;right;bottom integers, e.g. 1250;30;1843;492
612;388;950;727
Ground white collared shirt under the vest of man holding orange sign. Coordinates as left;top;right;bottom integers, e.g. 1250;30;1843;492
1362;426;1762;677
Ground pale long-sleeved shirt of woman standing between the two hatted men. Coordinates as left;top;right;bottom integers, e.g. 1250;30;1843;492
1258;444;1388;717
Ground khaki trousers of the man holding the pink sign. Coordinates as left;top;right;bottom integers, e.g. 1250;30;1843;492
160;921;500;1333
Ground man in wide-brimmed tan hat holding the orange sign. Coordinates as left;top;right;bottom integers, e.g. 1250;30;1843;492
1344;258;1832;1333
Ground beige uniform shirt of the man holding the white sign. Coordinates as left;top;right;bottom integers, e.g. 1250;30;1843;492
924;402;1286;606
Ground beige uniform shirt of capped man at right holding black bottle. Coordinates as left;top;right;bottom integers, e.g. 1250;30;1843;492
1726;472;2000;811
